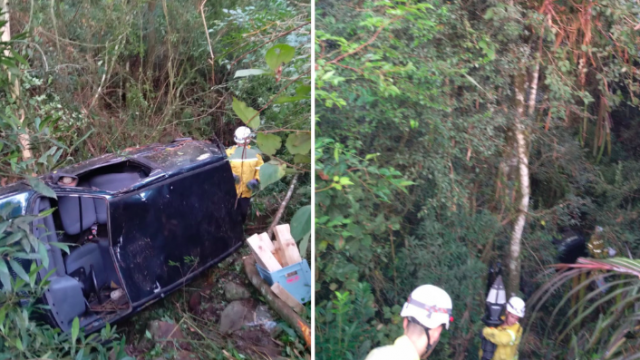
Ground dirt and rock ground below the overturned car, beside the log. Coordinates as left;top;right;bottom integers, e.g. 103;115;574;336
118;248;310;360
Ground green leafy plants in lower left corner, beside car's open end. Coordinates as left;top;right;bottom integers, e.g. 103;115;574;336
0;207;132;360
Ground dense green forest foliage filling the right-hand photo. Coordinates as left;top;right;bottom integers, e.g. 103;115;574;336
315;0;640;359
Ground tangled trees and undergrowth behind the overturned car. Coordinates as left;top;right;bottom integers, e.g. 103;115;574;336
0;1;310;205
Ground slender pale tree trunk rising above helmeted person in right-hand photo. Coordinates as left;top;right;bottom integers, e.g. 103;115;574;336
509;64;538;293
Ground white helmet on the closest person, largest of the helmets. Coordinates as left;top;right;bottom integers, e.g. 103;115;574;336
400;285;453;330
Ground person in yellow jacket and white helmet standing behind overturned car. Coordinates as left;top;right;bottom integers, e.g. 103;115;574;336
227;126;264;223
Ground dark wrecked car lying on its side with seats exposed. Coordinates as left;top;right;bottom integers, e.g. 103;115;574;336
0;139;244;333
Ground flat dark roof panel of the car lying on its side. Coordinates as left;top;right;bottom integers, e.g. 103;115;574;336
109;159;243;305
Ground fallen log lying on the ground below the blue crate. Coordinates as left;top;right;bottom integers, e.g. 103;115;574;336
243;255;311;346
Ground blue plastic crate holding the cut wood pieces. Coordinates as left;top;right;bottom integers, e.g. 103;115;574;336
256;259;311;304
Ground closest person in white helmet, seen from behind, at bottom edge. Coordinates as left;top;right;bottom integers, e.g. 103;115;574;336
365;285;453;360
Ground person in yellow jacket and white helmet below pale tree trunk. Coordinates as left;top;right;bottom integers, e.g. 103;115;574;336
480;296;525;360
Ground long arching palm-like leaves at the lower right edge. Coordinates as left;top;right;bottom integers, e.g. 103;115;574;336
526;258;640;360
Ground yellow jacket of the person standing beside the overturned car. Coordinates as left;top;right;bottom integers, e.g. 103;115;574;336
227;145;264;197
